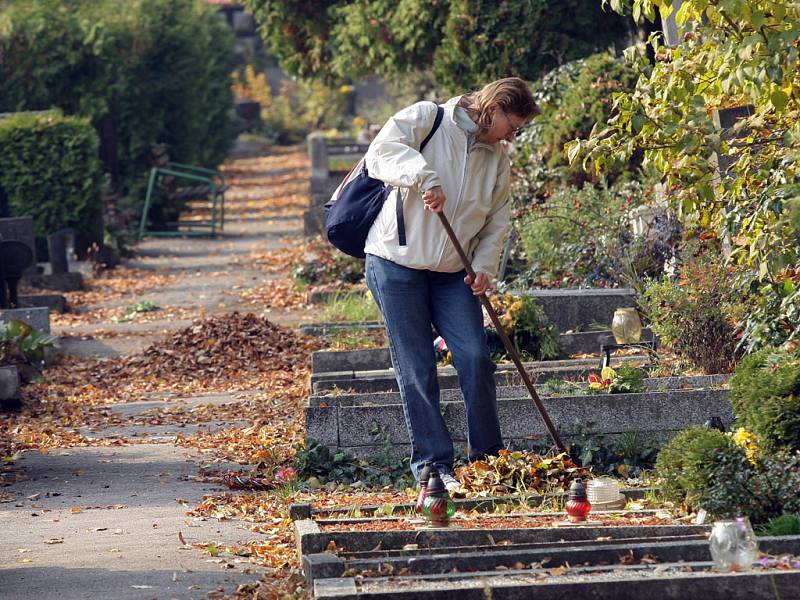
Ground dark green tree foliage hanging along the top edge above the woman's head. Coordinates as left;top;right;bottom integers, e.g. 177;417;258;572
246;0;632;90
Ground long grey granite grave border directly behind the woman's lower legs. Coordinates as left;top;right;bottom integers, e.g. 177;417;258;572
305;389;733;456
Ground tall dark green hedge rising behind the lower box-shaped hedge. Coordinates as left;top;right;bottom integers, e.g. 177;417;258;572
0;0;234;220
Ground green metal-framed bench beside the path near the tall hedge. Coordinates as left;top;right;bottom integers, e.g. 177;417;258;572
139;147;228;238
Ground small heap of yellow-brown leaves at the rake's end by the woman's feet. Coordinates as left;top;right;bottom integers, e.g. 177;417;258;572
456;450;590;496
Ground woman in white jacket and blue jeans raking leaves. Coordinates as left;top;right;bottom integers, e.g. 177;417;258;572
365;77;538;491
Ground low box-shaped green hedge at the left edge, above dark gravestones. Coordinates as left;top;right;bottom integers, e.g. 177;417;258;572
0;111;103;247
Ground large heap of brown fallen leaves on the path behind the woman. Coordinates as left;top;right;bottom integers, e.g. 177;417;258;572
105;312;319;382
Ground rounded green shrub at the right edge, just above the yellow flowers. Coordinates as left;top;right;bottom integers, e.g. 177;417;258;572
730;348;800;451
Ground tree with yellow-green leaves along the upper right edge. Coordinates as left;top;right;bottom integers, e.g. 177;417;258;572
566;0;800;348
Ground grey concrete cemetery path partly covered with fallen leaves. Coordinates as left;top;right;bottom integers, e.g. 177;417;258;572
0;144;307;600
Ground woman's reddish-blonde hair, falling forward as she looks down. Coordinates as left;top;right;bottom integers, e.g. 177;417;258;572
458;77;540;133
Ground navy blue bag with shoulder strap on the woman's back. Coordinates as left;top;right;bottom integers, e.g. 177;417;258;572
325;106;444;258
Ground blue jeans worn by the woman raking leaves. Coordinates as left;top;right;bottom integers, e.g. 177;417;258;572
366;254;503;478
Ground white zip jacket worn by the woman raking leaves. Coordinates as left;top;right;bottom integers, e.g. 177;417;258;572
364;97;510;278
